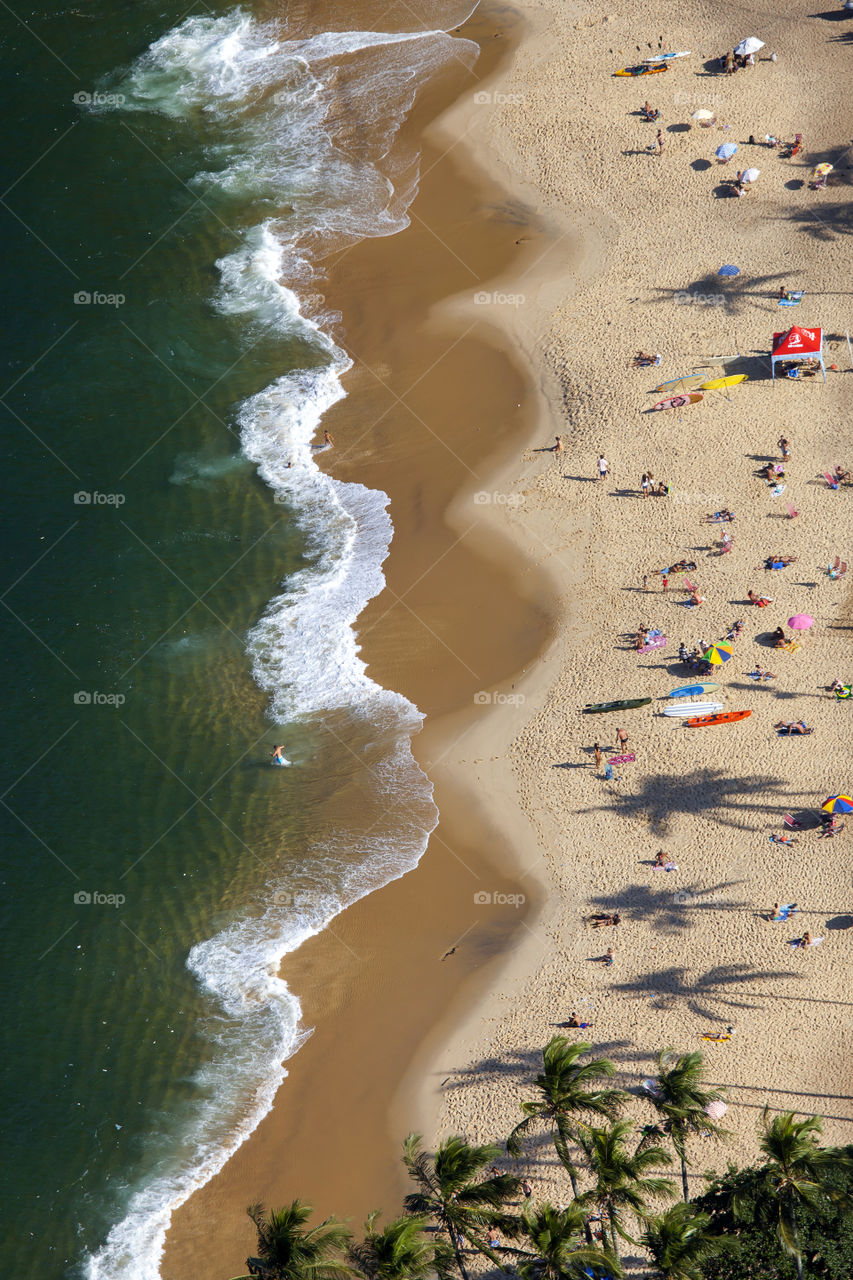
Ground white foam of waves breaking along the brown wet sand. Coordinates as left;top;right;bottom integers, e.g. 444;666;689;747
86;10;476;1280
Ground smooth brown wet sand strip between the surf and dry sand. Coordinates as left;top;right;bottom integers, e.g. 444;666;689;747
163;10;565;1280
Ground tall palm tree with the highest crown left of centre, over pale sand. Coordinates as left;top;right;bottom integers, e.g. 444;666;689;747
506;1036;628;1198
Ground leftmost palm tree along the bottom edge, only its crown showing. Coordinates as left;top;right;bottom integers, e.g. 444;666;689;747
236;1201;352;1280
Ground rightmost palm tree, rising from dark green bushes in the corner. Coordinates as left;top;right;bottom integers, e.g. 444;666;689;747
758;1107;853;1280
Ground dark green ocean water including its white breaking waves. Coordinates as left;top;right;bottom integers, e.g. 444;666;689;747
0;0;476;1280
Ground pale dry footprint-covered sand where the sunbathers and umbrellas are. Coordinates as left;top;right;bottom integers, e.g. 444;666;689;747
430;3;853;1193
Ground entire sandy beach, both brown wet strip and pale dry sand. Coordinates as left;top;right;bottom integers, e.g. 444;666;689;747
163;0;853;1280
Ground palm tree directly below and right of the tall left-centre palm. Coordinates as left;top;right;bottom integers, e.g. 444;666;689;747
579;1120;674;1258
